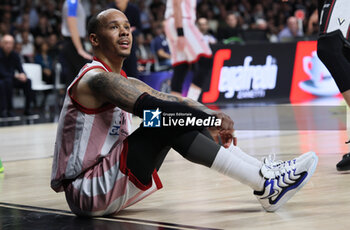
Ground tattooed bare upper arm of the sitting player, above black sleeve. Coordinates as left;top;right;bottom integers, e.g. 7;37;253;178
83;72;143;112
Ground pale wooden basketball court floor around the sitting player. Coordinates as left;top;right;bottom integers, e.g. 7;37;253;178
0;100;350;230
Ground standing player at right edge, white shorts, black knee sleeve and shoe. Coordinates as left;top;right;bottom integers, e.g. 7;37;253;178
317;0;350;171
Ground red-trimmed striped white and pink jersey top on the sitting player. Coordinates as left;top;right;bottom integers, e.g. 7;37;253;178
51;58;132;192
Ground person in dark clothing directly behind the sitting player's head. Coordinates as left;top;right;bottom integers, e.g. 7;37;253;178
108;0;142;78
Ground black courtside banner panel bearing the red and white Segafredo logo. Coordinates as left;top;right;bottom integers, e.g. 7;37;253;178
201;43;296;103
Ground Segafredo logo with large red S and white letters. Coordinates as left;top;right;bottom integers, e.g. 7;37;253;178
202;49;278;103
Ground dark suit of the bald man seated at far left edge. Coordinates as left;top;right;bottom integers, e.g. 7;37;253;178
0;49;33;116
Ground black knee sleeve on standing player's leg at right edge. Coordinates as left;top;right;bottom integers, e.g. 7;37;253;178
317;31;350;92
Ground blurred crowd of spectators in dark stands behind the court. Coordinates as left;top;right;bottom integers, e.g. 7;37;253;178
0;0;318;79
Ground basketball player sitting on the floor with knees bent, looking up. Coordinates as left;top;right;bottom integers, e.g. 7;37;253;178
51;9;318;216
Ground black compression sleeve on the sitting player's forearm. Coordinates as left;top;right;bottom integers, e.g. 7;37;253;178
133;93;212;119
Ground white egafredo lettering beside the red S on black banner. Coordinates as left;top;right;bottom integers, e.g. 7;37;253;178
218;55;278;99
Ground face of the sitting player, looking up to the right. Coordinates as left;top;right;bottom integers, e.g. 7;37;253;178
100;10;132;57
